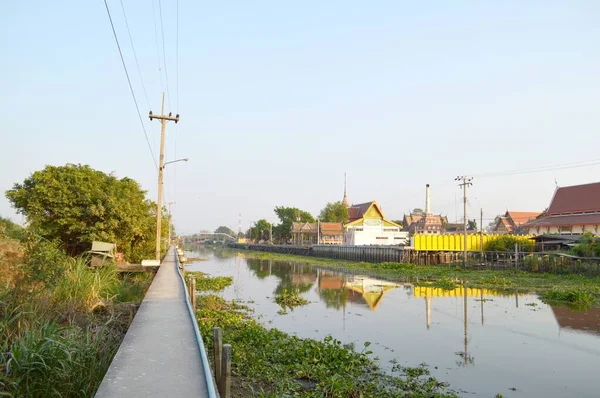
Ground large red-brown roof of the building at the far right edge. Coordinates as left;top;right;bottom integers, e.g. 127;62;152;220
548;182;600;215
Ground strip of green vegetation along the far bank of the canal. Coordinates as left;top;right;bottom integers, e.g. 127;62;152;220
222;249;600;305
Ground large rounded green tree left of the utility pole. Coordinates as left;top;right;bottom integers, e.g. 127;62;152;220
6;164;169;262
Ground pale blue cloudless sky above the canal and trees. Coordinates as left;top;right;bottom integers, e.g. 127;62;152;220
0;0;600;234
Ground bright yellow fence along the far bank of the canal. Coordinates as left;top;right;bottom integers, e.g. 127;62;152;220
413;234;531;251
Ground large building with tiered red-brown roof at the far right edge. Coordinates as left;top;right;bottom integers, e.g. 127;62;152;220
521;182;600;235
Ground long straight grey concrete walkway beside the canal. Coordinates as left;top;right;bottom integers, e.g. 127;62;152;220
96;248;208;398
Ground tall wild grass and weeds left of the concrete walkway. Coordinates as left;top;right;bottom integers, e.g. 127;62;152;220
0;241;151;397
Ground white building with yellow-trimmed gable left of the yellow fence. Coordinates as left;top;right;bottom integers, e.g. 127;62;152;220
344;201;408;246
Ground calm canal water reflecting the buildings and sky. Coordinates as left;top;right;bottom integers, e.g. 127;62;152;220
187;251;600;397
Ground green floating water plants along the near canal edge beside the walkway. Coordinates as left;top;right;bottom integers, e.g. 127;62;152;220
190;276;456;398
